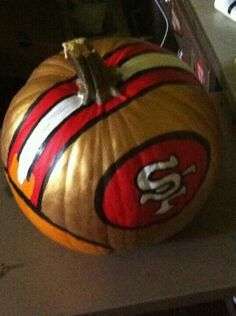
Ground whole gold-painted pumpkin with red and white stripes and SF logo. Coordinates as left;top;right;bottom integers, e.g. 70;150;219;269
1;37;221;254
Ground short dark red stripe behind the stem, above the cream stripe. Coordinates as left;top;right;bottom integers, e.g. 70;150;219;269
105;42;165;66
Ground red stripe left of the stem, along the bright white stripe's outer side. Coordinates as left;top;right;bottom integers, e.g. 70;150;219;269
8;80;78;166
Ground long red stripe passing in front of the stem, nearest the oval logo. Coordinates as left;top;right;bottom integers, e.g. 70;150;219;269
31;69;199;206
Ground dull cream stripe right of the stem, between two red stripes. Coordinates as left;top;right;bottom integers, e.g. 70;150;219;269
119;53;192;80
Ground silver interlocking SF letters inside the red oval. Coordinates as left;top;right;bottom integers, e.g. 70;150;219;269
137;155;196;215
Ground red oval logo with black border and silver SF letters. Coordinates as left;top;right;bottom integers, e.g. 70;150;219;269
95;132;210;229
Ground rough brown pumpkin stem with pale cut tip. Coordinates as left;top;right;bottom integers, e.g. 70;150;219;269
62;38;120;105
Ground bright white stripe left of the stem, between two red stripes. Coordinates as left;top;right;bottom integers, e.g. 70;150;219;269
18;95;83;184
